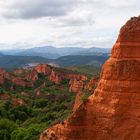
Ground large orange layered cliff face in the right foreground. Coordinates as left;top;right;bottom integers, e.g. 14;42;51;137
40;16;140;140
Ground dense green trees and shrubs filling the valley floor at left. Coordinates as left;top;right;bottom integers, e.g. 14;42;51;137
0;68;76;140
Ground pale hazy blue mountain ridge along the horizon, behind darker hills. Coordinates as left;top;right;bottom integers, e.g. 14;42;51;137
1;46;111;59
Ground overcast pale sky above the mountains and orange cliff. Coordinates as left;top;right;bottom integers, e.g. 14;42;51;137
0;0;140;50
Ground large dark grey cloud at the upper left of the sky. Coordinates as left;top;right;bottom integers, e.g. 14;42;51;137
3;0;78;19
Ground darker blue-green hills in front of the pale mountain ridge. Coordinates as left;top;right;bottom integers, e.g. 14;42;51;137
0;55;108;69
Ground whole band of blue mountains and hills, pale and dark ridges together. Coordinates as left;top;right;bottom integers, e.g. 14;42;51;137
0;46;110;69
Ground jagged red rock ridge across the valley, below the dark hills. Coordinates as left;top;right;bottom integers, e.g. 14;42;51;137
0;64;87;89
